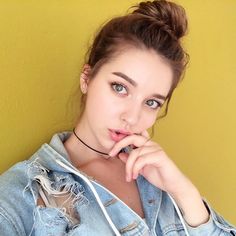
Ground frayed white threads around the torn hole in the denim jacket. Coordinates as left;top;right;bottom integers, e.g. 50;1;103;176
23;156;88;231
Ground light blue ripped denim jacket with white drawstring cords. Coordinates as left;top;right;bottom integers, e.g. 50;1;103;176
0;132;236;236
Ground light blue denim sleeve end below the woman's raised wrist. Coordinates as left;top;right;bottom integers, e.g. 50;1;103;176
186;199;236;236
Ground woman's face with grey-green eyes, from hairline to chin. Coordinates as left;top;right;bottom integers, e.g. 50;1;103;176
79;48;173;151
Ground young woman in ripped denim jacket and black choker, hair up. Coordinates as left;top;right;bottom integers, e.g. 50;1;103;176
0;0;236;236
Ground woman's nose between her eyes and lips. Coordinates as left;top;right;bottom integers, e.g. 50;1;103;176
121;101;142;126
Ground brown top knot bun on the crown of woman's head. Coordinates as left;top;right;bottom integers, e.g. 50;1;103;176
133;0;188;40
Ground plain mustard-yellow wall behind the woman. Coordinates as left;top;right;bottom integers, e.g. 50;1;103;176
0;0;236;224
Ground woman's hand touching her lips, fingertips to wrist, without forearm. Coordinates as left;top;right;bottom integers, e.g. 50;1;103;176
110;131;189;194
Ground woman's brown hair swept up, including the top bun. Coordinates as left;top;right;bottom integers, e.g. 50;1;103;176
81;0;188;116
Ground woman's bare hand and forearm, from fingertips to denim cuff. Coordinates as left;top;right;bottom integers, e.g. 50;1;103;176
109;131;209;227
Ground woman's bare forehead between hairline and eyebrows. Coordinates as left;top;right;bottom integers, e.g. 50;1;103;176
101;47;173;96
